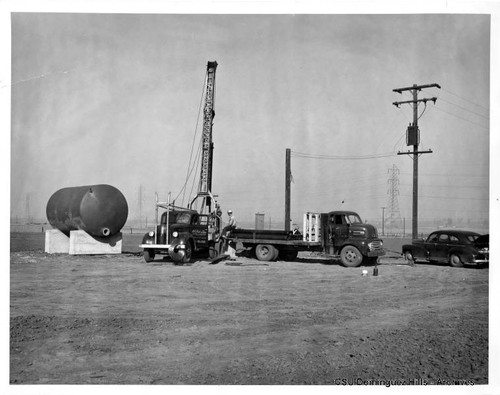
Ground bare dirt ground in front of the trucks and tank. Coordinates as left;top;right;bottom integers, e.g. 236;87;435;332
10;234;489;386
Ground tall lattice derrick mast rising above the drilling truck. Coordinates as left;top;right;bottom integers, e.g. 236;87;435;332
190;61;217;213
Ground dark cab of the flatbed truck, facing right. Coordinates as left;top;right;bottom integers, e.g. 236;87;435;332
321;211;385;267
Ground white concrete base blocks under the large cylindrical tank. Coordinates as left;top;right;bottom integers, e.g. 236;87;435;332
45;229;123;255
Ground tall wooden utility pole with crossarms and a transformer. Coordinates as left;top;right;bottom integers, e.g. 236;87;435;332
392;84;441;239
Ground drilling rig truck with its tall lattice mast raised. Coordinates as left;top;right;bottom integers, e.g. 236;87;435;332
141;61;222;264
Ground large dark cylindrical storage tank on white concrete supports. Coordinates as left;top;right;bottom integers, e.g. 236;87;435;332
47;184;128;237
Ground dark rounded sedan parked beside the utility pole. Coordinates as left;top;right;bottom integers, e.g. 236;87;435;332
402;230;489;267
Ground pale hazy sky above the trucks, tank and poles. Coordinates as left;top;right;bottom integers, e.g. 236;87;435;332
0;9;491;229
